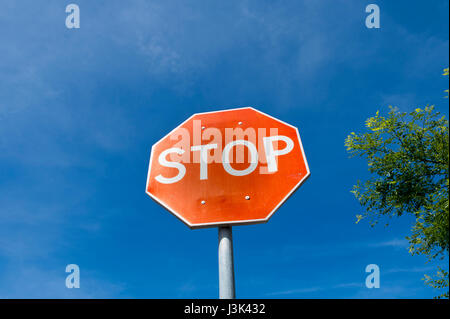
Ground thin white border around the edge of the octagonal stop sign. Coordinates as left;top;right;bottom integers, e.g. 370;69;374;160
145;106;311;229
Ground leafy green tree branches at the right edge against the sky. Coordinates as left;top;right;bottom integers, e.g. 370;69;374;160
345;68;449;298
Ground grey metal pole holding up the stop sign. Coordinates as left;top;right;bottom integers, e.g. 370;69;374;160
219;226;236;299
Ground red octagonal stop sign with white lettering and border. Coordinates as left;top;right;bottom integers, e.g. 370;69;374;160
146;107;310;228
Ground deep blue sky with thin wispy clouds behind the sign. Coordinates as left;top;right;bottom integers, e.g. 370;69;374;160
0;0;449;298
